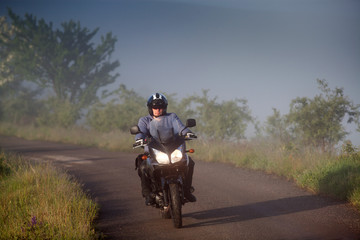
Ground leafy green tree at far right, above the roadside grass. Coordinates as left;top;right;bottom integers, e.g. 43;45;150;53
287;79;360;151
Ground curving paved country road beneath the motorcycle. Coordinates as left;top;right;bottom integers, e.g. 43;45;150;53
0;136;360;240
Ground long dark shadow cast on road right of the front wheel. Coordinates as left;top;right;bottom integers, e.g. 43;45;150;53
183;195;339;228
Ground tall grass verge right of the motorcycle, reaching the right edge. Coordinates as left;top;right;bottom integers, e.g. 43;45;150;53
193;139;360;211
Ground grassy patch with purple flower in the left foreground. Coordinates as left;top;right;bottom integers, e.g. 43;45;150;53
0;151;98;239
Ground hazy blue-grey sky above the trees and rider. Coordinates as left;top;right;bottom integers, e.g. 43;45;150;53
0;0;360;145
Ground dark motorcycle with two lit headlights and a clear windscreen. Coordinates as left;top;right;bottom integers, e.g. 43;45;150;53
130;117;197;228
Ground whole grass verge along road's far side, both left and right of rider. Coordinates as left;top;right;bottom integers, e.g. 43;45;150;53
0;123;360;211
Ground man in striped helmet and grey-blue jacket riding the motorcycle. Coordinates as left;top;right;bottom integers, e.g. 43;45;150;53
135;93;196;206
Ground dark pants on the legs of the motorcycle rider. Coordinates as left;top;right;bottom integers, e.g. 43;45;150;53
136;157;195;197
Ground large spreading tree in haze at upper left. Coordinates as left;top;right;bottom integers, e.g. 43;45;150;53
1;9;119;125
